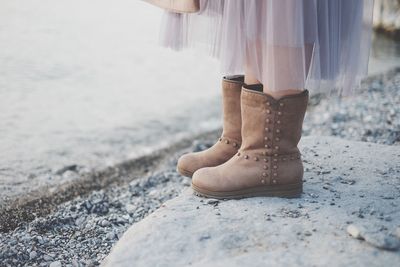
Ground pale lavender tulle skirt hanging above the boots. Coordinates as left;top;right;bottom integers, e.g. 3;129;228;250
161;0;373;95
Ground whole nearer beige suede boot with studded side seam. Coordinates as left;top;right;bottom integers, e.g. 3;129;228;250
192;88;308;199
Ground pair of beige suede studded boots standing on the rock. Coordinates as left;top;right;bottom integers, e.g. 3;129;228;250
177;76;308;199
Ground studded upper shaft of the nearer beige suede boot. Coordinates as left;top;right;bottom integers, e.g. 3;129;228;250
241;87;308;156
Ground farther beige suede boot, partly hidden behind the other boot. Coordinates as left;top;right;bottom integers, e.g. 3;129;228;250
177;75;244;177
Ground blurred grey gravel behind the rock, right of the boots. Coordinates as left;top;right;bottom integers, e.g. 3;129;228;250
303;69;400;145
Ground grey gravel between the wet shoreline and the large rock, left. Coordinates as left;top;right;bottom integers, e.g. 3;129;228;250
0;158;190;267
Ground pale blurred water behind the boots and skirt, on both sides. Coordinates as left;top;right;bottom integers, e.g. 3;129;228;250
0;0;400;204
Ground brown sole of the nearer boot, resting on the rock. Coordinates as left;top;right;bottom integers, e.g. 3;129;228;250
192;183;303;199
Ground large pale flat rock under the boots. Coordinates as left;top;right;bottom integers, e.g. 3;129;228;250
103;137;400;266
